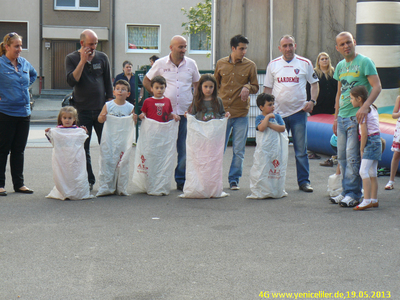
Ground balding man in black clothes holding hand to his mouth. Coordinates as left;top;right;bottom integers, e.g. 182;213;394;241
65;29;113;190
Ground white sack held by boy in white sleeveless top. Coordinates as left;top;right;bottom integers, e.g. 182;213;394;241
96;115;135;196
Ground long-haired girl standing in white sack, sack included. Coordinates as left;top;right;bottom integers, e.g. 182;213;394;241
180;74;230;198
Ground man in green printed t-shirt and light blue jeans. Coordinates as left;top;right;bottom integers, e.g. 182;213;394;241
331;31;382;207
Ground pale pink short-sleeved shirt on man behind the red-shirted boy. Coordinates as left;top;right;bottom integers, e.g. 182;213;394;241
146;55;200;115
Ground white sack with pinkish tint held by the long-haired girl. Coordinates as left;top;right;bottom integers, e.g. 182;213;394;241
180;115;228;198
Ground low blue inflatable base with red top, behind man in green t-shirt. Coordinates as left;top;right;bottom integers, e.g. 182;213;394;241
307;106;397;168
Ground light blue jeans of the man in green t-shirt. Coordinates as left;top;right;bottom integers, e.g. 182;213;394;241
337;117;362;200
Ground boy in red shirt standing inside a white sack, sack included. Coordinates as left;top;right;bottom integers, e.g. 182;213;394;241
132;76;180;196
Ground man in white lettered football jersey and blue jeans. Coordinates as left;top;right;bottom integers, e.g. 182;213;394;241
264;35;319;192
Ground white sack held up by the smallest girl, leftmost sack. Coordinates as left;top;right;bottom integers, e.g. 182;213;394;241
46;128;94;200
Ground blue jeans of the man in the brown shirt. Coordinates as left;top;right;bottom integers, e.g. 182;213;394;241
225;117;249;183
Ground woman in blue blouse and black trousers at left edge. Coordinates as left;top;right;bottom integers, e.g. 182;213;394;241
0;32;37;196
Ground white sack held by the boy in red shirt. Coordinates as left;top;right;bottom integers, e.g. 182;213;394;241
132;118;179;196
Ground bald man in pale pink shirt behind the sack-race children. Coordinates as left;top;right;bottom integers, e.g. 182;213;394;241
143;35;200;191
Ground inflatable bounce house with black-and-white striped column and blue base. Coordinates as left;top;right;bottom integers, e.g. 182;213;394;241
307;0;400;170
